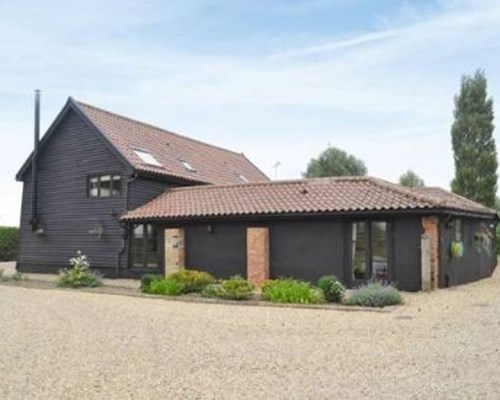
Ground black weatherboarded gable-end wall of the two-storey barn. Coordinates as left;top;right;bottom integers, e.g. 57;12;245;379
18;111;126;272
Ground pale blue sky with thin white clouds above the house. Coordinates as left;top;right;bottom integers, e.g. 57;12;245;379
0;0;500;225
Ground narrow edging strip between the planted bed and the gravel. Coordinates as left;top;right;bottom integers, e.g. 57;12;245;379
0;279;398;314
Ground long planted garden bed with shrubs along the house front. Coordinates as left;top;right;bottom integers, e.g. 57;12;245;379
0;252;403;311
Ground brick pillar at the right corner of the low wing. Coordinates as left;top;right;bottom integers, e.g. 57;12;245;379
421;216;439;290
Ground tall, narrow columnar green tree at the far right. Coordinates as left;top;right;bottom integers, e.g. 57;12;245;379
451;70;498;207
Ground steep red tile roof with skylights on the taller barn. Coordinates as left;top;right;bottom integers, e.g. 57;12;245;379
75;101;269;185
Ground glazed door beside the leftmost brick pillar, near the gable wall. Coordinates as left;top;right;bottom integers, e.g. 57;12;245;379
131;224;158;268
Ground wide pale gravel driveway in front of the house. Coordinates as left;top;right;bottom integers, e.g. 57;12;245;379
0;271;500;399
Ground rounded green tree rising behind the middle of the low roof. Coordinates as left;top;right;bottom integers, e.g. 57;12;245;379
304;146;367;178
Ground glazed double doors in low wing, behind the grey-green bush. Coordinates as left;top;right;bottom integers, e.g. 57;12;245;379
349;221;389;284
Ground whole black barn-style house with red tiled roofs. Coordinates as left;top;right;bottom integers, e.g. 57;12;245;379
17;98;497;291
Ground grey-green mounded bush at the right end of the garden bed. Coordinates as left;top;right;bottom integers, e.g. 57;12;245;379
345;282;403;307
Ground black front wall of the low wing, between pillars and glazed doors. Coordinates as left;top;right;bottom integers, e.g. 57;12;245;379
178;216;422;291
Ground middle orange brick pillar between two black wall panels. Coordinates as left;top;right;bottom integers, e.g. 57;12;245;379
247;228;269;286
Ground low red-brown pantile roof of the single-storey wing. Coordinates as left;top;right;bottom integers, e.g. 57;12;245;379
123;177;495;220
